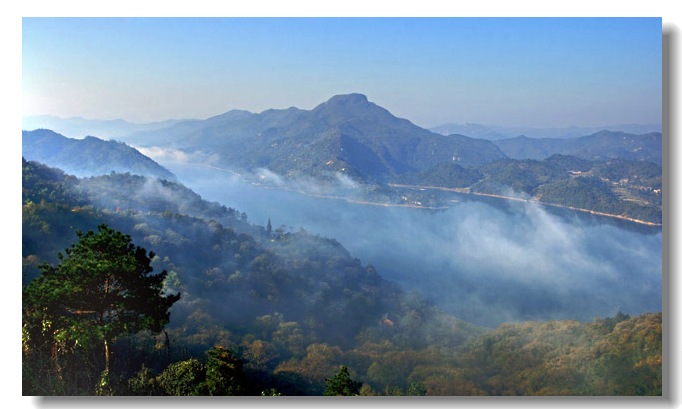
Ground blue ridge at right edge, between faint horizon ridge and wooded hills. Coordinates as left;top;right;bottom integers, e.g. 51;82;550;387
495;131;663;165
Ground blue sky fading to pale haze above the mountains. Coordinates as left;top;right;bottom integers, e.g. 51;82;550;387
22;18;662;127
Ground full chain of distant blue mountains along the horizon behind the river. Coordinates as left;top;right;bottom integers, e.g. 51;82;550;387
24;93;662;177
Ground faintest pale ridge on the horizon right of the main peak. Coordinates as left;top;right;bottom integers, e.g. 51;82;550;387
430;123;662;141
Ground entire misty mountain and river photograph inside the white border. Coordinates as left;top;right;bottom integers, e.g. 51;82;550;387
22;18;670;397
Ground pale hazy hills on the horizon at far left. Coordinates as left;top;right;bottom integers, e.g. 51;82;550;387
22;115;191;139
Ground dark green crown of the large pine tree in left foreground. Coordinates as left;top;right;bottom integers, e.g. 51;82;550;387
25;225;180;341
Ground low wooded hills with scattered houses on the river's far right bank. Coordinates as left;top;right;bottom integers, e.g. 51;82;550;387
395;154;663;225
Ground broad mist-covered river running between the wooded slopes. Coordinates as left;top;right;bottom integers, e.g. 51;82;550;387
161;162;663;327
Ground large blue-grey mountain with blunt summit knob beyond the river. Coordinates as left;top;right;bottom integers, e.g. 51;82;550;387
128;94;505;182
